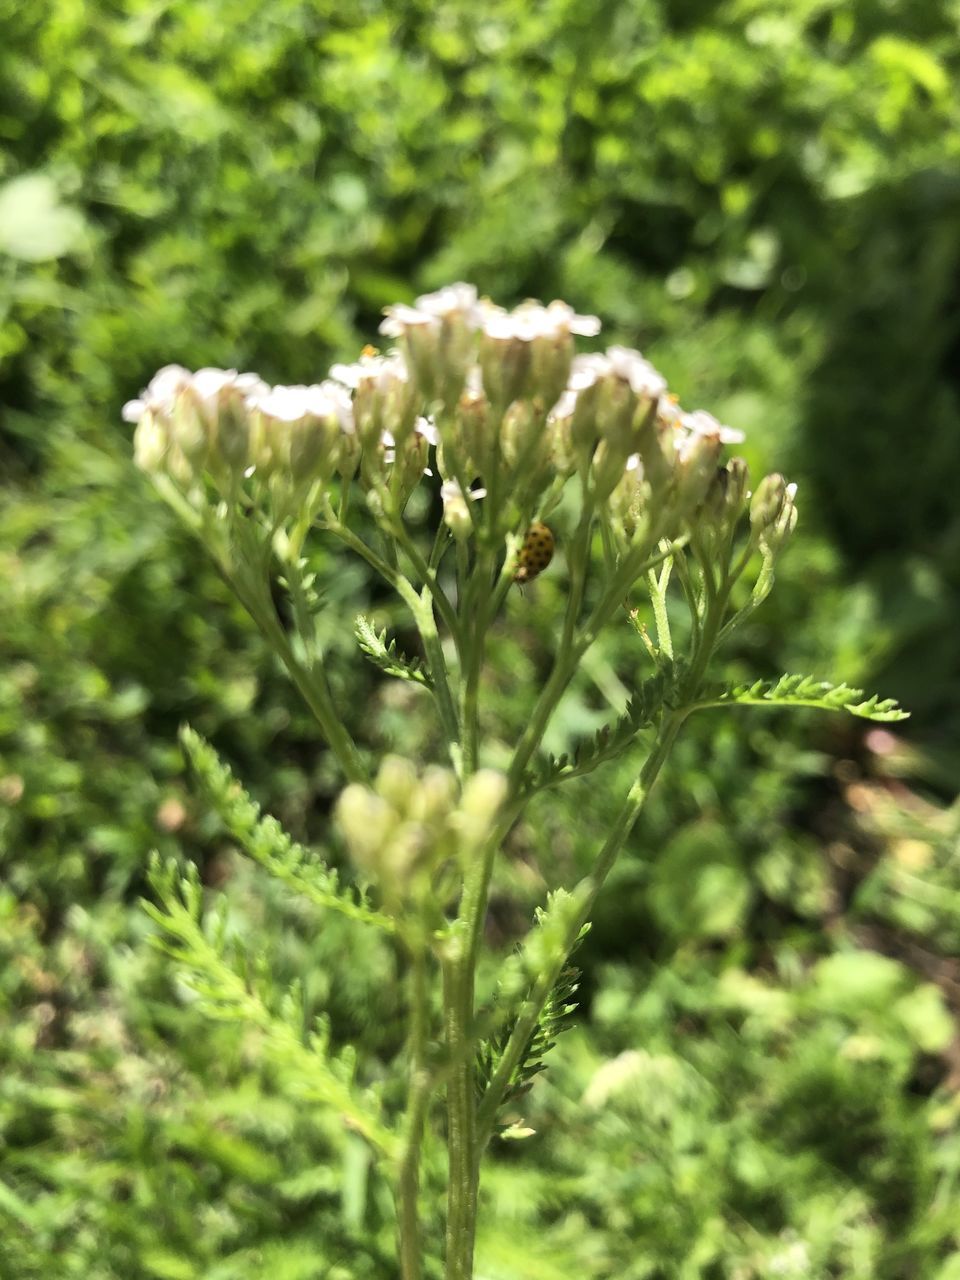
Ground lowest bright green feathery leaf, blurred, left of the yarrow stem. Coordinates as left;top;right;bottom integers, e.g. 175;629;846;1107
142;854;397;1156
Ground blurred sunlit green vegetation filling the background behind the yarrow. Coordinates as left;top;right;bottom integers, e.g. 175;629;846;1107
0;0;960;1280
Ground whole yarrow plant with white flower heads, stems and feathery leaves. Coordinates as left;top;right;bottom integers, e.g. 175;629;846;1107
124;284;904;1280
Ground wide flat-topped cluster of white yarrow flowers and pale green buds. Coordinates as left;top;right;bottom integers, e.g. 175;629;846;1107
123;284;788;550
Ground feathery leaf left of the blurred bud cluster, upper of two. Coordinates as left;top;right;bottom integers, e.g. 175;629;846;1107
180;724;394;932
